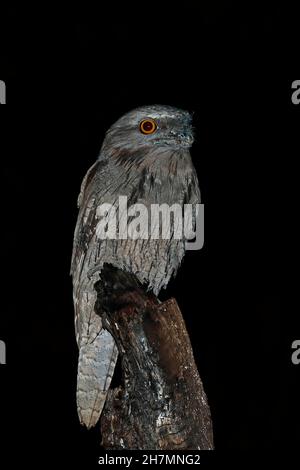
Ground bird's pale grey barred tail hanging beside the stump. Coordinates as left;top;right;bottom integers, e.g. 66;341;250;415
77;329;118;429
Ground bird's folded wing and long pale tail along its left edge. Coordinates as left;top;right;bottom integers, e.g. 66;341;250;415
71;161;118;428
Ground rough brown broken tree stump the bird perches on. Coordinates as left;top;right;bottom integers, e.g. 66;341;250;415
95;265;213;450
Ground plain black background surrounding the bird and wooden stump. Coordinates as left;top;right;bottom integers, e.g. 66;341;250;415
0;2;300;463
